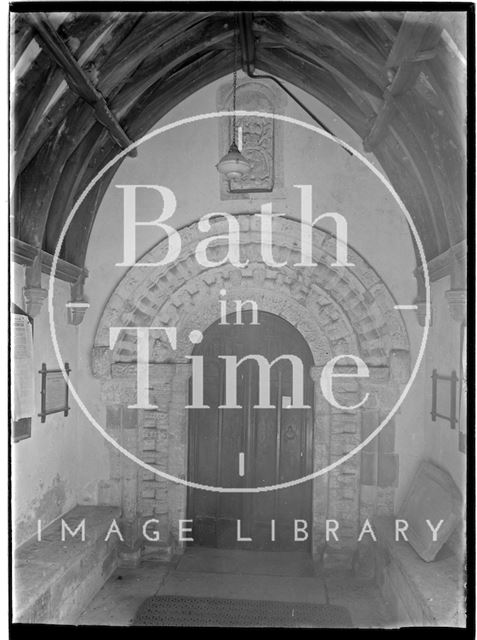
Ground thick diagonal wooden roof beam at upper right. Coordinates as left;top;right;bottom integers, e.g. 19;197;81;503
363;11;442;151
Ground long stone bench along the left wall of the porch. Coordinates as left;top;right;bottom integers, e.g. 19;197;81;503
13;506;120;624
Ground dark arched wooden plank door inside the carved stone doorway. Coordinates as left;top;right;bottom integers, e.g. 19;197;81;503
188;312;313;551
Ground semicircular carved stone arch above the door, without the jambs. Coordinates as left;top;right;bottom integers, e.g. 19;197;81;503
94;214;409;366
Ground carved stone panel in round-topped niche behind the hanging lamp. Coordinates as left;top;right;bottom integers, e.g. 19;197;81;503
217;78;286;200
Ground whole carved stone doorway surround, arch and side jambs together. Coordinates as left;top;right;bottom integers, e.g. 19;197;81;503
92;214;410;562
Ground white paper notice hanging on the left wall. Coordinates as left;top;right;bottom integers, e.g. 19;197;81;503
12;313;35;420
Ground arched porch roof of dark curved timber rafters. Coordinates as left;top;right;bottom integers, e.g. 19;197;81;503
11;11;465;282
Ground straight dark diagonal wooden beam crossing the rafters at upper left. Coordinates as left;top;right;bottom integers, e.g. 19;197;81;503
27;13;137;157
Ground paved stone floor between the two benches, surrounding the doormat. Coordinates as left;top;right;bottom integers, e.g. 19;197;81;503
78;548;386;628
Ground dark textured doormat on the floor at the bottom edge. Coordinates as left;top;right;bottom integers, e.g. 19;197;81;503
133;596;354;628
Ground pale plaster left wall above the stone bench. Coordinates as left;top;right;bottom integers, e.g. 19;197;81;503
11;264;79;546
